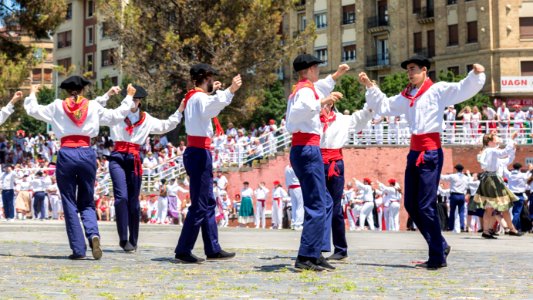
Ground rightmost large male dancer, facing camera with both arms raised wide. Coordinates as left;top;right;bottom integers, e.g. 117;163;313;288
359;55;485;270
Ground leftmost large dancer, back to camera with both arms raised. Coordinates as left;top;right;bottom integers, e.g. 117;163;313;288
24;76;135;259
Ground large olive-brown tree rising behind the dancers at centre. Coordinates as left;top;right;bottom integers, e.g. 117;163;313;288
99;0;314;121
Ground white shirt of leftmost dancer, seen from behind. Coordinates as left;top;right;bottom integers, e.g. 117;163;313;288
24;94;134;139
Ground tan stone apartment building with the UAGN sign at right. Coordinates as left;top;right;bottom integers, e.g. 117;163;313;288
284;0;533;106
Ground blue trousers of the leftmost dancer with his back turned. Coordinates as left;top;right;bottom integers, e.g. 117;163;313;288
56;147;100;255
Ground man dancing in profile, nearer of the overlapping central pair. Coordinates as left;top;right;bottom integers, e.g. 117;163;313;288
286;54;342;272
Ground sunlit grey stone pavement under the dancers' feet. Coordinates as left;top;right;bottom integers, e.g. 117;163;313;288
0;221;533;299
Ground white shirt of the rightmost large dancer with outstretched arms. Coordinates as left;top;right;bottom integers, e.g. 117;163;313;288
366;71;485;134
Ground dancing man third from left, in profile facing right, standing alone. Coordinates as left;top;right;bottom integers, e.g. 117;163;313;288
175;64;242;263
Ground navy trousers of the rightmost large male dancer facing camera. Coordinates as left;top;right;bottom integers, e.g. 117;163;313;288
404;149;448;265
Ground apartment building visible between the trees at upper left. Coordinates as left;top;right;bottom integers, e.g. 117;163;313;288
54;0;122;87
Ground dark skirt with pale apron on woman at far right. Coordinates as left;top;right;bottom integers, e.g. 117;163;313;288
474;172;518;211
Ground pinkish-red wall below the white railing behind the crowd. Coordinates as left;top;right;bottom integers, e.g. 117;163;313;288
225;146;533;229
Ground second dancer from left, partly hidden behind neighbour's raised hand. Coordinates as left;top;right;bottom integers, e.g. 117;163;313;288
101;85;183;252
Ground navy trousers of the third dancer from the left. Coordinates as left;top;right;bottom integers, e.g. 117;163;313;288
174;147;221;255
